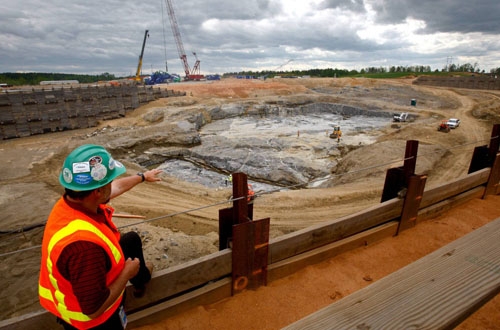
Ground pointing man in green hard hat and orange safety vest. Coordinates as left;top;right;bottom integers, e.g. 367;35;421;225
39;144;161;329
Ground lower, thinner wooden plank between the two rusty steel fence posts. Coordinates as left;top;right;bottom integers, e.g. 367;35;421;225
268;221;399;282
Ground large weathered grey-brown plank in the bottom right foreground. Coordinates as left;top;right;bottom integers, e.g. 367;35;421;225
284;218;500;330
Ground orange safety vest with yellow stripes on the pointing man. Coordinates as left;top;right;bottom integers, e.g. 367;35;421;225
38;198;125;329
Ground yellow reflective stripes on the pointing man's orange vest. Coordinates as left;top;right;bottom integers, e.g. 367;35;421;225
38;219;123;324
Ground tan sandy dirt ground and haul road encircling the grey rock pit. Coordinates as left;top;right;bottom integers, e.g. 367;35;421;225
0;79;500;319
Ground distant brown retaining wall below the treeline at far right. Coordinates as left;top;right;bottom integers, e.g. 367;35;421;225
413;76;500;90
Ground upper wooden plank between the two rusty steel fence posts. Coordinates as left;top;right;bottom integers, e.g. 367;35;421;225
269;199;403;263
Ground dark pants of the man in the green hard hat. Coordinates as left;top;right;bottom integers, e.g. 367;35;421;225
57;231;151;330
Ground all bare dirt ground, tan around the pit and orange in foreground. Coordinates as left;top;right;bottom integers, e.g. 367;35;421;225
0;78;500;329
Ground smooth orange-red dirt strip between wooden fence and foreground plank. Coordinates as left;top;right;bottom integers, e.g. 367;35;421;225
133;195;500;330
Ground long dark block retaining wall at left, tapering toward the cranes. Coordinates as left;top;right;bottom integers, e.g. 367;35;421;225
0;85;186;140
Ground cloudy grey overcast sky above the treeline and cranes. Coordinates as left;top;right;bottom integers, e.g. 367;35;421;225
0;0;500;76
